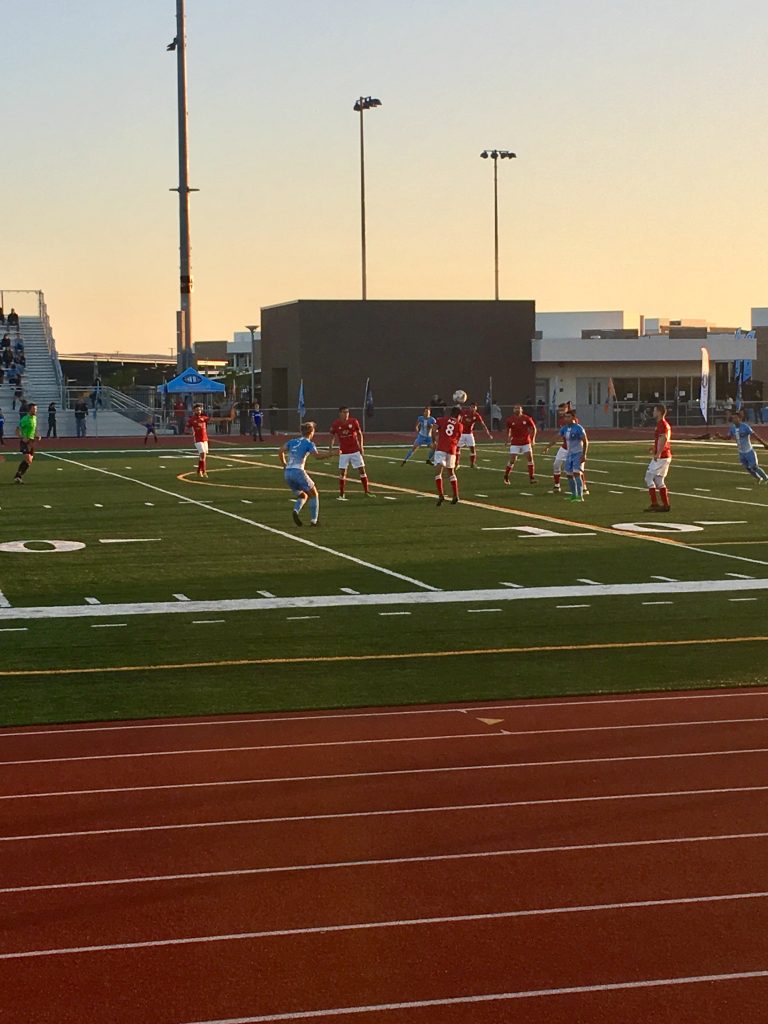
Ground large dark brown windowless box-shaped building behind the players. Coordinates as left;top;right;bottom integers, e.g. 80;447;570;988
261;300;535;430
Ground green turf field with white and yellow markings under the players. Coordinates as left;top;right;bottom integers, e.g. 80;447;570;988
0;441;768;725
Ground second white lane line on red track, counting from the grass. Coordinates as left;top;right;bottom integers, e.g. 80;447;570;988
0;716;768;767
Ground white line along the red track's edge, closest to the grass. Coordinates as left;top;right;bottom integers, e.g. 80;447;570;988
6;687;768;740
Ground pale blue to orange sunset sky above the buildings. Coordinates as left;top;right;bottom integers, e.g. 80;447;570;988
6;0;768;352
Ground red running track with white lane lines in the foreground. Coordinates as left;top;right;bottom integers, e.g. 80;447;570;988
0;689;768;1024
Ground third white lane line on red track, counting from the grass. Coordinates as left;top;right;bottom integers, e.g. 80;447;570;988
0;745;768;801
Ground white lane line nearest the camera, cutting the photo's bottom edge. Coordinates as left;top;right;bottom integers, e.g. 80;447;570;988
167;971;768;1024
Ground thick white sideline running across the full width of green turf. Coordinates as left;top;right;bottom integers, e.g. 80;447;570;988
0;577;768;622
